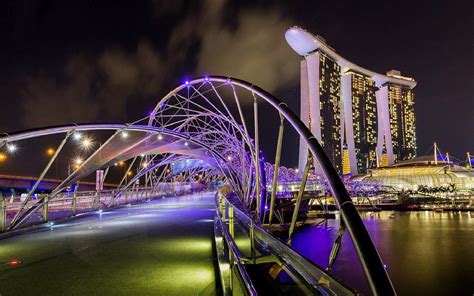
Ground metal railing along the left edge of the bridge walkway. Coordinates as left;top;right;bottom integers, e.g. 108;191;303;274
0;183;204;233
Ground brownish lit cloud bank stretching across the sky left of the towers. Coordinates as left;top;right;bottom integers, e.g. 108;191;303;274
22;0;299;126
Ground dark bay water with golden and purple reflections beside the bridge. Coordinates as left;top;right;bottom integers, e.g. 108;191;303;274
293;211;474;295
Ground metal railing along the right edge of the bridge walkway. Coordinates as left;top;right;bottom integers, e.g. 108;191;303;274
214;193;357;295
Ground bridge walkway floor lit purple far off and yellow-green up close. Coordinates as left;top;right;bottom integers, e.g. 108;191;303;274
0;193;216;296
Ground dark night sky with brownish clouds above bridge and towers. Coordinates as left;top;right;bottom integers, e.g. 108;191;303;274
0;0;474;169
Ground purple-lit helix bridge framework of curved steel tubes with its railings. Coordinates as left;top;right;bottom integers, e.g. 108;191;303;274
0;76;395;295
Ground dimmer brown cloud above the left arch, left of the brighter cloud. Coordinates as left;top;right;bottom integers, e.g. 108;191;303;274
22;41;165;126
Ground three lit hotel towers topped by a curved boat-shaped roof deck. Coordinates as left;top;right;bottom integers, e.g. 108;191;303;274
285;27;416;175
